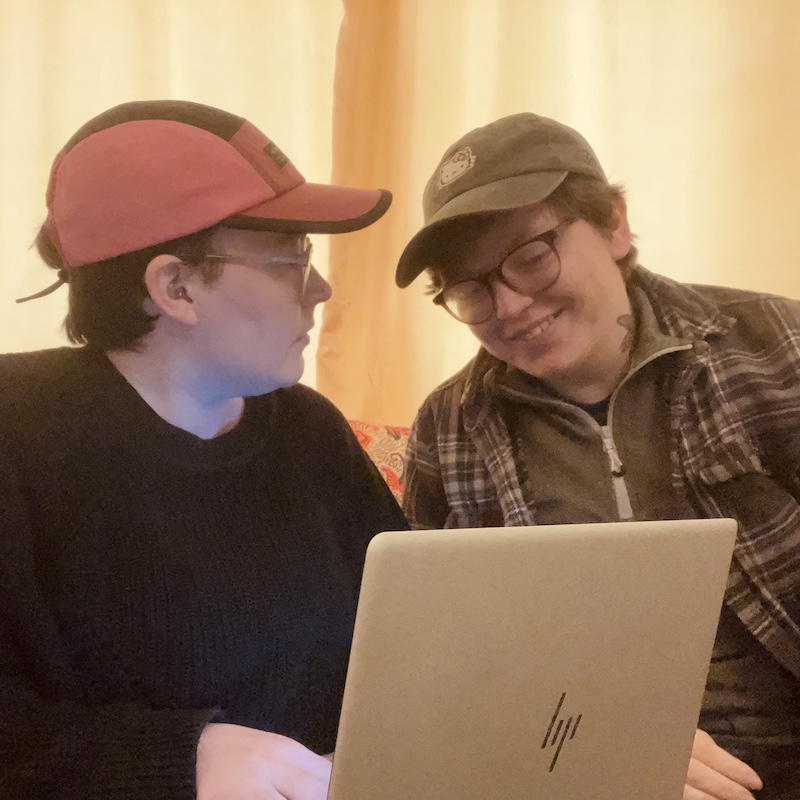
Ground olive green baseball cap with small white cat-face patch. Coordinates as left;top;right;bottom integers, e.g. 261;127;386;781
395;113;607;288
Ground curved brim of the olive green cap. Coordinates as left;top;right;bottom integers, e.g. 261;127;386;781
395;170;569;289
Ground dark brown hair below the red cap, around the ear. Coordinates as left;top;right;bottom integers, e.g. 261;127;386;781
35;225;222;351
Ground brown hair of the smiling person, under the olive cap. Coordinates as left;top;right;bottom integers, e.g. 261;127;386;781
420;172;638;293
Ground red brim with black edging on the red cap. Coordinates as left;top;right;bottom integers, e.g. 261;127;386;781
223;183;392;233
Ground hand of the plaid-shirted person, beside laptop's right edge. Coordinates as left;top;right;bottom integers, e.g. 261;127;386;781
683;730;761;800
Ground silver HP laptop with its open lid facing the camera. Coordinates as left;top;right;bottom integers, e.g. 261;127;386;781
328;519;736;800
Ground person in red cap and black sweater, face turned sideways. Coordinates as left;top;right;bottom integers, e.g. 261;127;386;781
0;101;406;800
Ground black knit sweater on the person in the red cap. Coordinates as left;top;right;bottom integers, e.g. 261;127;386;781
0;348;406;800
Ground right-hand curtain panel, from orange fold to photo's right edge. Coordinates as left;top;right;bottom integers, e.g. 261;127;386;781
318;0;800;425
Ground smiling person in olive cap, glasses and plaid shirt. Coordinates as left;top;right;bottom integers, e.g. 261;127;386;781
396;113;800;800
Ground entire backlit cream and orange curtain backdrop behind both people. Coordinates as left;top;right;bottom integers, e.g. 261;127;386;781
0;0;800;425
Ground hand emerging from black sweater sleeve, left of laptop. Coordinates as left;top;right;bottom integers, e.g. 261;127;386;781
197;722;331;800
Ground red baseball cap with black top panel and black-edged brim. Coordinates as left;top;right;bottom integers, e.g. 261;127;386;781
45;100;392;268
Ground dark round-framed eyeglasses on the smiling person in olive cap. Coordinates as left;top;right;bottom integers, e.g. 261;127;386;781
433;217;577;325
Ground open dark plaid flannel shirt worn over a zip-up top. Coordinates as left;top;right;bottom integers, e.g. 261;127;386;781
410;267;800;678
